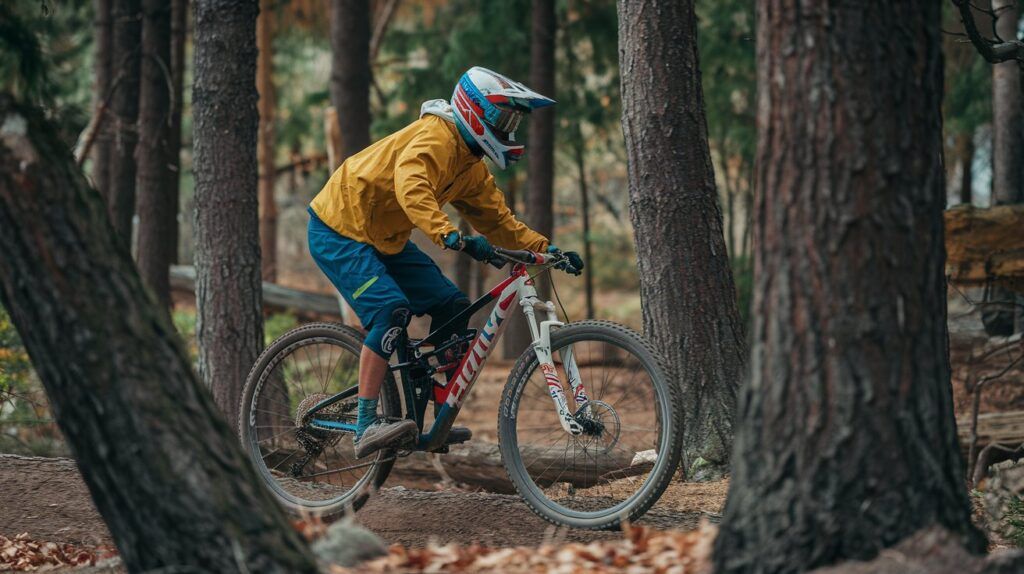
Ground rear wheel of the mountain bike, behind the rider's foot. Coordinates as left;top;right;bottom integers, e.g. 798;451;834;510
239;323;401;516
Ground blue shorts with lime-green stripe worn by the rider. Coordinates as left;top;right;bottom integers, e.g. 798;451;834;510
308;209;466;358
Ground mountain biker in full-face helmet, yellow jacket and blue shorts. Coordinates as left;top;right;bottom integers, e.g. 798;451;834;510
308;67;584;458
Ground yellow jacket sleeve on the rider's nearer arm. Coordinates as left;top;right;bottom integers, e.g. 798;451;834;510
394;124;458;247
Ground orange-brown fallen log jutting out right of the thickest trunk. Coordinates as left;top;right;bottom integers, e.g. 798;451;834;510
945;205;1024;292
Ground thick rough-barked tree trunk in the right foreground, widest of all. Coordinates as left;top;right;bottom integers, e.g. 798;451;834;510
714;0;985;572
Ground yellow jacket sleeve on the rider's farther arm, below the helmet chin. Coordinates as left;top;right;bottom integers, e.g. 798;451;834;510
452;162;549;252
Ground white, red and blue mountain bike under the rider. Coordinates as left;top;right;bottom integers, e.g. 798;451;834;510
239;249;683;529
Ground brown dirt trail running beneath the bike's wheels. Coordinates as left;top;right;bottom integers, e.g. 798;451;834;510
0;454;724;546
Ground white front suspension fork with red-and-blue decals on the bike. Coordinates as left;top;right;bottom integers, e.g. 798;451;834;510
519;285;589;435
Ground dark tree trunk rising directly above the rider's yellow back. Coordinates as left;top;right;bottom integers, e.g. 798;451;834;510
331;0;372;162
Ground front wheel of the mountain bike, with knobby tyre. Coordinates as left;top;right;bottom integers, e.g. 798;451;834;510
498;321;683;530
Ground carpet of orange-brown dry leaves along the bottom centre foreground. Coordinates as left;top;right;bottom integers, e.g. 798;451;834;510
331;521;718;574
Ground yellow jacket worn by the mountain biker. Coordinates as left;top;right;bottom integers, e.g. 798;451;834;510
310;115;548;255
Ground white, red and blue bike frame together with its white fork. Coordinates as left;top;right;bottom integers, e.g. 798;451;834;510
309;254;588;451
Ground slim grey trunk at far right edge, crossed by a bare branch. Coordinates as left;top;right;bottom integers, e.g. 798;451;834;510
992;0;1024;206
